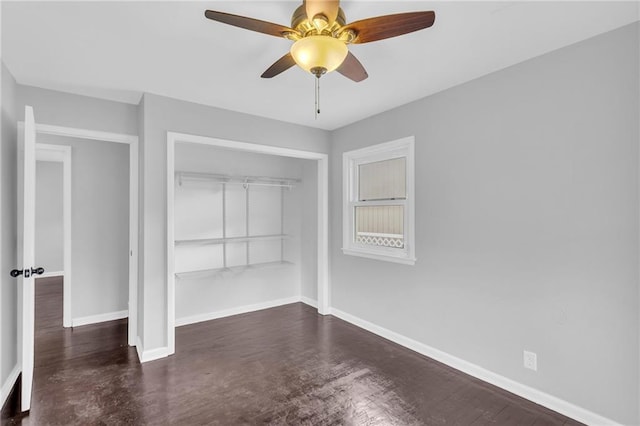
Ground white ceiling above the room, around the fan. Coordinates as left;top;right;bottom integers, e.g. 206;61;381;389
2;1;639;130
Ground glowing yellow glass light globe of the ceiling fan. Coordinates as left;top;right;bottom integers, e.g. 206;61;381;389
291;35;349;72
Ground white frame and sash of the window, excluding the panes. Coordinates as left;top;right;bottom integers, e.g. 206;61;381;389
342;136;416;265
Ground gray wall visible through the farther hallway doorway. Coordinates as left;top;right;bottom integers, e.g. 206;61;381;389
35;161;64;272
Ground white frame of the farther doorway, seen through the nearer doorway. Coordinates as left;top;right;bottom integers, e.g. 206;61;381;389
36;145;73;327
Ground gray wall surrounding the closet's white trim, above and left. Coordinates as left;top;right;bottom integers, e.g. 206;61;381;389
138;94;329;350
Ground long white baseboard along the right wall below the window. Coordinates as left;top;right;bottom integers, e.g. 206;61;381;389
331;308;621;426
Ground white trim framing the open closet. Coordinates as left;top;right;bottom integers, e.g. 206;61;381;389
167;132;331;355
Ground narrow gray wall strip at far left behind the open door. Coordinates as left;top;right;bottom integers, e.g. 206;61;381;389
0;62;18;392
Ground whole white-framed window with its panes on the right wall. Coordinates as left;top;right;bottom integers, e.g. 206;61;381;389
342;136;416;265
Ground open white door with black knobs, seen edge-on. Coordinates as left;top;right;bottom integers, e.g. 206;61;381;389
11;106;44;411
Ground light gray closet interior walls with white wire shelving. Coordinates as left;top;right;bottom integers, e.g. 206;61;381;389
173;143;317;326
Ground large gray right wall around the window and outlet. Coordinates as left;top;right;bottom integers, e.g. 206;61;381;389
330;24;640;424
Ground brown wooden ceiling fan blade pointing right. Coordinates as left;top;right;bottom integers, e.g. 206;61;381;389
343;11;436;43
